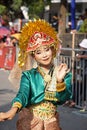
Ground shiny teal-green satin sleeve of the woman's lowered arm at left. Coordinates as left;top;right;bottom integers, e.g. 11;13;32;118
12;72;30;107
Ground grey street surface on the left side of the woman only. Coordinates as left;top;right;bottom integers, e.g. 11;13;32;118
0;70;17;130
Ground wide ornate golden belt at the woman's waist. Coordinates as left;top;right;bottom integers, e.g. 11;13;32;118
29;101;57;120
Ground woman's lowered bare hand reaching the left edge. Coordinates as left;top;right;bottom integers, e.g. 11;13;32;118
0;107;18;121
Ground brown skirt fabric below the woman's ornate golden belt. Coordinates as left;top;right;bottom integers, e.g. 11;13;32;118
17;105;62;130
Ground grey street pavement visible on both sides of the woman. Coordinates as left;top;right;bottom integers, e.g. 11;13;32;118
0;69;87;130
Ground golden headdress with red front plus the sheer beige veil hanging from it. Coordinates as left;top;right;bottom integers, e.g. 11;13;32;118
8;20;60;87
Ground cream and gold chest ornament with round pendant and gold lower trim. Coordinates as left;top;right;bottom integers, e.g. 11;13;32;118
38;65;58;101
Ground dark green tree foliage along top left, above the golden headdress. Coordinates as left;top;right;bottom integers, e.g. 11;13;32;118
0;0;51;18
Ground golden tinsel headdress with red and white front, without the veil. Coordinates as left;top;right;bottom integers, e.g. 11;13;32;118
18;19;59;67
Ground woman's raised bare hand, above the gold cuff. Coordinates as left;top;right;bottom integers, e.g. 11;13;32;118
56;63;70;82
